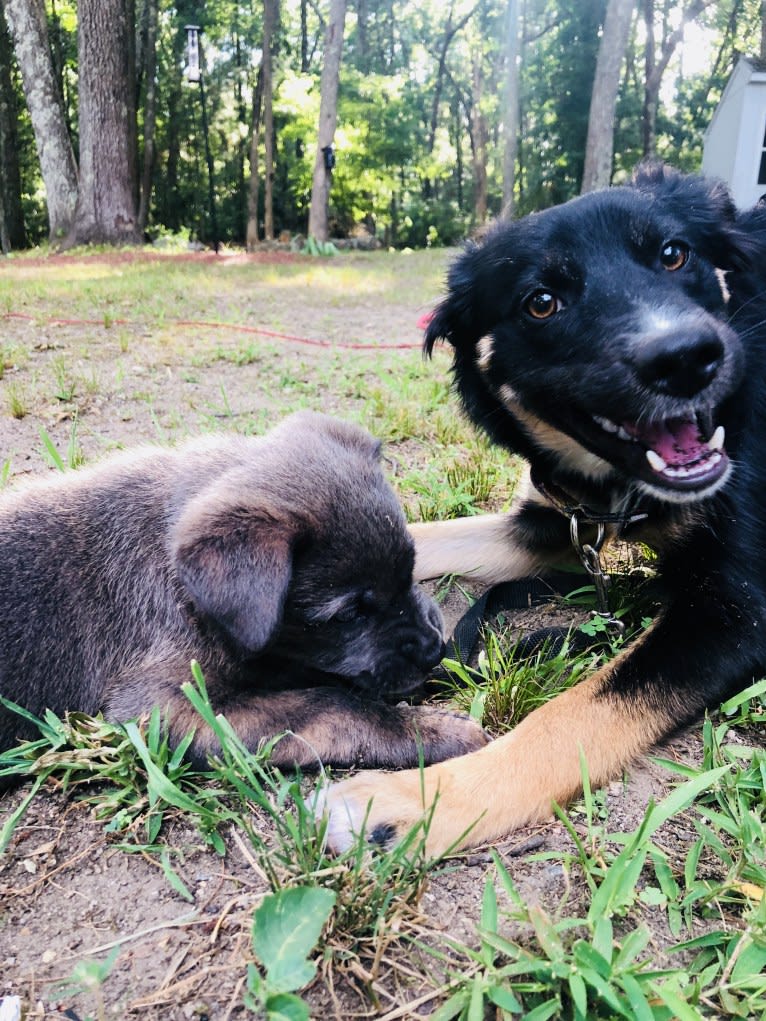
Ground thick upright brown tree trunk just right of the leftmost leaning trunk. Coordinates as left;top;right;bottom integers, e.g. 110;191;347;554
67;0;140;245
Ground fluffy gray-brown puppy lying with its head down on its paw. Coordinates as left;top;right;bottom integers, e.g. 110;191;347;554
0;412;485;767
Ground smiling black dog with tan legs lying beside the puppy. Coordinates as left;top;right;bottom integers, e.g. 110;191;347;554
328;165;766;850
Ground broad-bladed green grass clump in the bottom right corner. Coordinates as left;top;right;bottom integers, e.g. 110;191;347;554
432;765;766;1021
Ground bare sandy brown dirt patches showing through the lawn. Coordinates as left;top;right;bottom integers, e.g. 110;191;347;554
0;249;755;1021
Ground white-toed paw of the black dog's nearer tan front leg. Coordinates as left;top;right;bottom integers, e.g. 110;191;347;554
316;770;428;855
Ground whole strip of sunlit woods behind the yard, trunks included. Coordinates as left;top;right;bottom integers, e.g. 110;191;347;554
0;0;766;253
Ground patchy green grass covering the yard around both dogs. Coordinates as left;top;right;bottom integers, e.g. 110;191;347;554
0;252;766;1021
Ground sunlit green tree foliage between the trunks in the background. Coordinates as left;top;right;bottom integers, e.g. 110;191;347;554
4;0;761;247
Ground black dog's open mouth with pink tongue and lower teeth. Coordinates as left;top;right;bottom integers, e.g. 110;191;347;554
592;412;729;493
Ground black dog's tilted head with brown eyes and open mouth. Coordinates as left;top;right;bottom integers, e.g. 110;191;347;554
426;164;749;502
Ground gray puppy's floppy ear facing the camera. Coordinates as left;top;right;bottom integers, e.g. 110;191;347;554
172;493;299;652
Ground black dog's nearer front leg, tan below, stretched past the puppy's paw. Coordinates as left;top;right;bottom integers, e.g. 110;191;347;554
320;591;764;854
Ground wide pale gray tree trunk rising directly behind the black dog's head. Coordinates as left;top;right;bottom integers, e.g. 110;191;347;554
580;0;634;193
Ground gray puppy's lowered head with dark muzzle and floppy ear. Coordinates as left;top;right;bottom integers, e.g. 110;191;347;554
172;414;443;696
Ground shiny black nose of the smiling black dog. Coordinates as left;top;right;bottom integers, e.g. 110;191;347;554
634;327;724;397
